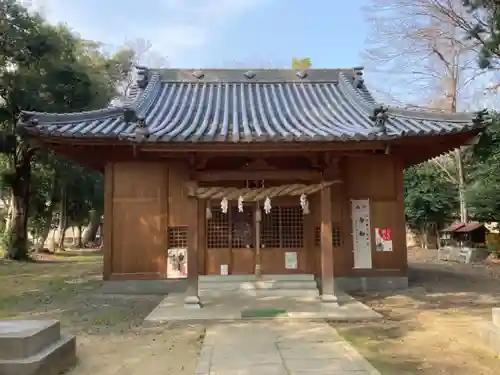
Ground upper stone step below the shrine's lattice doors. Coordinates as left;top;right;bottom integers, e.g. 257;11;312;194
198;280;318;290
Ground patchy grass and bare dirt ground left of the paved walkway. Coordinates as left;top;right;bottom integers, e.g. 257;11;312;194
0;250;204;375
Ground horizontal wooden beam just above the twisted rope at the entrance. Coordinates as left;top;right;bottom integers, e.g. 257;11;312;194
193;169;322;182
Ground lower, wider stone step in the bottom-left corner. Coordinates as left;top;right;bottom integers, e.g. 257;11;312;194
0;336;76;375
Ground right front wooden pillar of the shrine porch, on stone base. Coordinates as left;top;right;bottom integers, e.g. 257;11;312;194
320;186;338;305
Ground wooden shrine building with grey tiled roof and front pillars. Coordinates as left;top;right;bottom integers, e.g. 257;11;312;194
19;67;487;304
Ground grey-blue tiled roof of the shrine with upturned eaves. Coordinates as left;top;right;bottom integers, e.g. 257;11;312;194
19;68;485;142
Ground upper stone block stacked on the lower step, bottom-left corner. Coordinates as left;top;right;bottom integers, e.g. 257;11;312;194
0;320;61;362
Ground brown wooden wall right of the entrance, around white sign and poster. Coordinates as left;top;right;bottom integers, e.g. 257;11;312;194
332;155;407;277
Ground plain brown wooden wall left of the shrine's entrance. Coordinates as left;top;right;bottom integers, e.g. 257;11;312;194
104;162;188;279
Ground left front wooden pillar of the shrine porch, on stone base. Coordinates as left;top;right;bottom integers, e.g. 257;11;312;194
184;191;201;309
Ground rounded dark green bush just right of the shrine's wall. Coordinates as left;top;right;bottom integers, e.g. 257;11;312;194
405;162;458;228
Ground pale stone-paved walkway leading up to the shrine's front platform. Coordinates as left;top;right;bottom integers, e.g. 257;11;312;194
196;320;380;375
